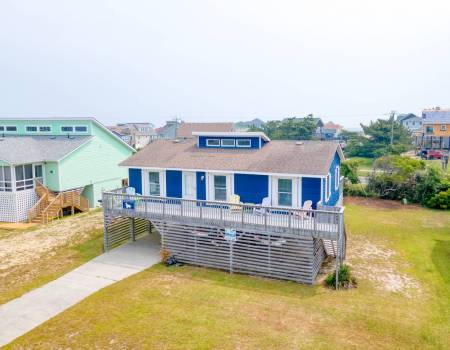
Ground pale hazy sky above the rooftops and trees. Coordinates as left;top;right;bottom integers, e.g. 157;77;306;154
0;0;450;129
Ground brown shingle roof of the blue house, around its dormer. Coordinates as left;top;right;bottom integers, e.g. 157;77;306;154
120;139;339;176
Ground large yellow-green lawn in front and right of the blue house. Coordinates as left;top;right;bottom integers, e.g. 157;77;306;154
9;199;450;349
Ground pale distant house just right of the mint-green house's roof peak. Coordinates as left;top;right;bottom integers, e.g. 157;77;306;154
109;123;158;150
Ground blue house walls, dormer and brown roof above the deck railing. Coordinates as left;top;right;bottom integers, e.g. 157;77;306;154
121;132;343;208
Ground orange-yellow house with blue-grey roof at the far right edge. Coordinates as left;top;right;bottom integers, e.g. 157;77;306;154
422;107;450;150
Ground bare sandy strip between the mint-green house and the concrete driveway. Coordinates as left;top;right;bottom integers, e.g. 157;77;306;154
0;212;103;276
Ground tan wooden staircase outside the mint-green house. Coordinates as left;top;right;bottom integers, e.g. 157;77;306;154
28;181;89;224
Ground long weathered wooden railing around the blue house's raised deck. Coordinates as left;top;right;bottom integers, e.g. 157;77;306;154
102;191;344;239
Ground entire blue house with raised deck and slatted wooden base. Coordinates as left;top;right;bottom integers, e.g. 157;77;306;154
103;131;345;283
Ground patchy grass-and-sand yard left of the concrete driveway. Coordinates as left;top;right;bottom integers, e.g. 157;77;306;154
0;211;103;304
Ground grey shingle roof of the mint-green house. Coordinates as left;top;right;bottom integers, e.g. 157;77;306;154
0;136;93;164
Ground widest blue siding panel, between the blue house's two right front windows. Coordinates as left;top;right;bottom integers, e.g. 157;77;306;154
234;174;269;204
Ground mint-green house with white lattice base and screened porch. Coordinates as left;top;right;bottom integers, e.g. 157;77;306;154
0;118;134;222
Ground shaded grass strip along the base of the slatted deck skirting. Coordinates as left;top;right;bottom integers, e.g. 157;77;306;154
150;263;322;298
